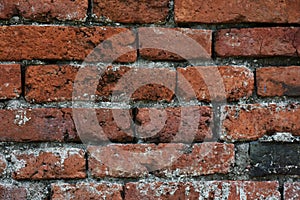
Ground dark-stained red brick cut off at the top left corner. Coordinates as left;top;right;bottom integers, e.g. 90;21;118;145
0;0;88;21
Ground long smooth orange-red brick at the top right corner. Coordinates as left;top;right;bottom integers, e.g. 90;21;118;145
175;0;300;23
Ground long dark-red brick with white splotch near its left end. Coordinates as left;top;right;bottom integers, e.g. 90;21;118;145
0;108;133;143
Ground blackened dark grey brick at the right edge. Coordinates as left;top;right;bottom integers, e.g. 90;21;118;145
250;142;300;176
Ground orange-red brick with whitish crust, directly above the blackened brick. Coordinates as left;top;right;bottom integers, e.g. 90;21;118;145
222;104;300;141
